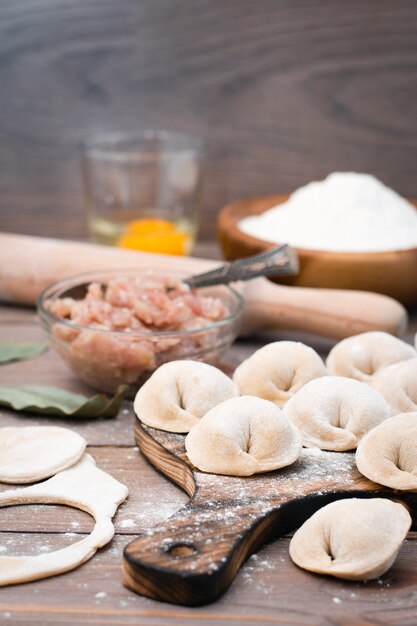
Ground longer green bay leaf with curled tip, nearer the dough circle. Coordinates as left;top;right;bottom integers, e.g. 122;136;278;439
0;385;129;418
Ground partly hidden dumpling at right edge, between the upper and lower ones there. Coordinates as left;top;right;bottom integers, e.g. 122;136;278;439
372;358;417;415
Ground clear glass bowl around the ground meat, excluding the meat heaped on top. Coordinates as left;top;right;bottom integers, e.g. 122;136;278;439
38;269;243;392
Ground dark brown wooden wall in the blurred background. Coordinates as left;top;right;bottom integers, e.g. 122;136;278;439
0;0;417;237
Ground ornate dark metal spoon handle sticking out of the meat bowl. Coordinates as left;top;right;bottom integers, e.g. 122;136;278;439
183;244;299;288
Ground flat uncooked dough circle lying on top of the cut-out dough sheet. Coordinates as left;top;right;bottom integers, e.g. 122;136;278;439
0;426;87;484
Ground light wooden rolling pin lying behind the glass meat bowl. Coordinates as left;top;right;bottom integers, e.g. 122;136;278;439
0;233;407;339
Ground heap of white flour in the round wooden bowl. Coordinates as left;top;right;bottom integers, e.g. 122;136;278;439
239;172;417;252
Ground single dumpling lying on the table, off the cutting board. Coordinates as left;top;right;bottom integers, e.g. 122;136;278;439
290;498;411;580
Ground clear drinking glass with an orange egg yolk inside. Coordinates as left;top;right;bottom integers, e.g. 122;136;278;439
82;130;204;254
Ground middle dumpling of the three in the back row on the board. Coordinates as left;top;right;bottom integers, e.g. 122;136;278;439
233;341;327;407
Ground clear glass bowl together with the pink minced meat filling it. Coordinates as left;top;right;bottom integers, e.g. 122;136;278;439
38;270;243;392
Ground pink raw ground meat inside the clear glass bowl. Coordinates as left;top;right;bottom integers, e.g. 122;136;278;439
47;276;229;391
